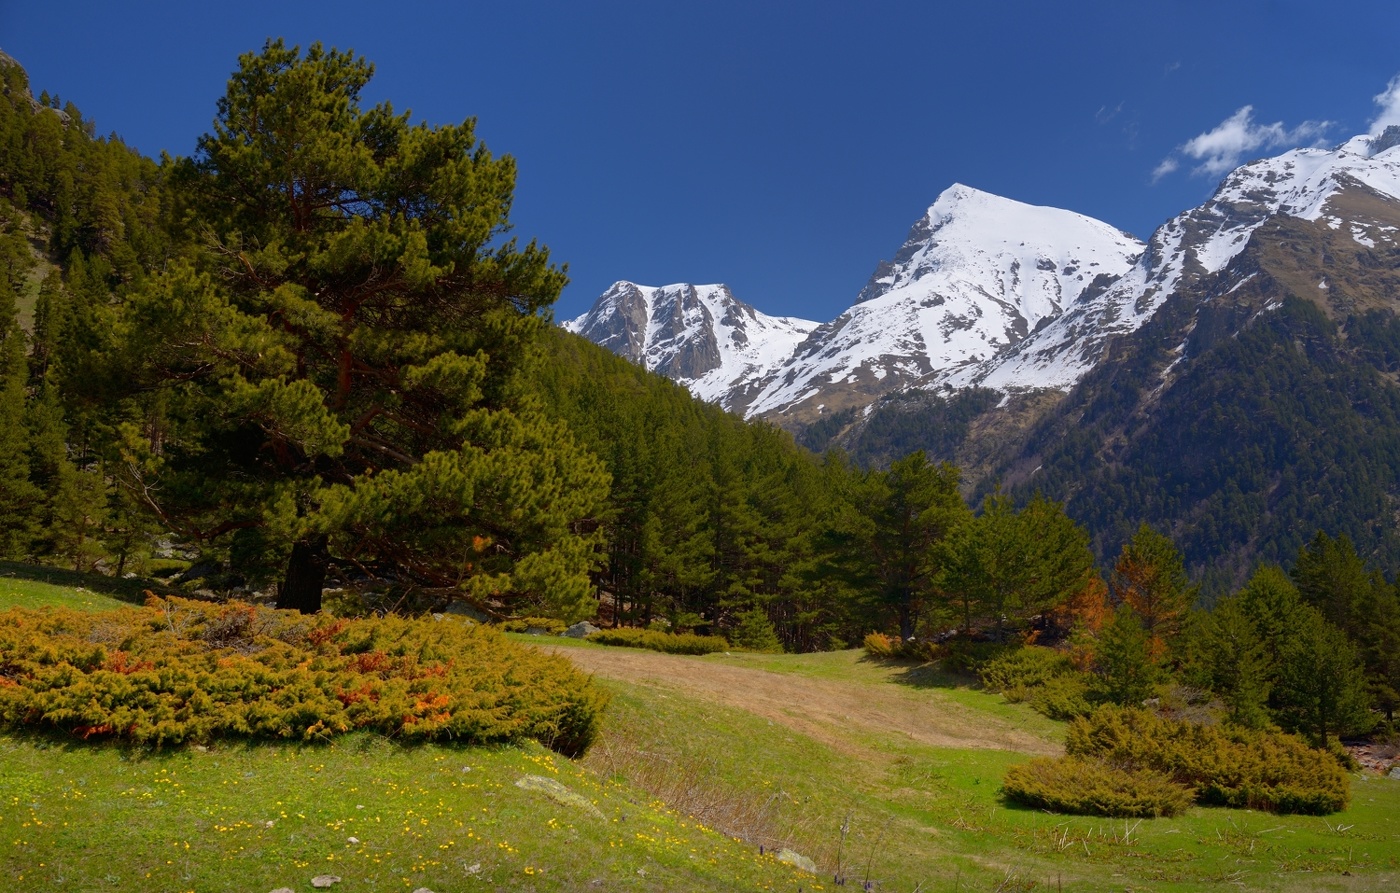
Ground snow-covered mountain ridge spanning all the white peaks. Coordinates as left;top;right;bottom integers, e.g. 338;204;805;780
564;127;1400;431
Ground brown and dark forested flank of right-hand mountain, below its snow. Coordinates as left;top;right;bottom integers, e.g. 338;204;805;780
1001;186;1400;591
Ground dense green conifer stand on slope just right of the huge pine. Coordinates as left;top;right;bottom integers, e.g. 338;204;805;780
532;332;864;651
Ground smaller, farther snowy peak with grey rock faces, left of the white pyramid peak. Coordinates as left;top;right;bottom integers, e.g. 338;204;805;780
563;281;818;410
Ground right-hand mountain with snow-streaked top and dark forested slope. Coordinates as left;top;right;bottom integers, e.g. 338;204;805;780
836;132;1400;592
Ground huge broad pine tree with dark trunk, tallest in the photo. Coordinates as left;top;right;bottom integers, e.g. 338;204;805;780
116;41;608;619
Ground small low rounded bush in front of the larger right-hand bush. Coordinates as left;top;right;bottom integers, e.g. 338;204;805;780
1001;757;1191;819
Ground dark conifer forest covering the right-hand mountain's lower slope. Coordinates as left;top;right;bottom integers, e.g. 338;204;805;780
1015;282;1400;596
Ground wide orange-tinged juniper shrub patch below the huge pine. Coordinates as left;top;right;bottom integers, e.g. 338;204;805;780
0;598;606;754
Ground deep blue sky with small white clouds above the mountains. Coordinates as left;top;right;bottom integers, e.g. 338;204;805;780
0;0;1400;321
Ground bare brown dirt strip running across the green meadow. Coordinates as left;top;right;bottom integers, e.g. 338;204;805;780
553;648;1061;756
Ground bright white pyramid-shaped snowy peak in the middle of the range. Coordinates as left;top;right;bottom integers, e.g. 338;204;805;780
748;185;1144;427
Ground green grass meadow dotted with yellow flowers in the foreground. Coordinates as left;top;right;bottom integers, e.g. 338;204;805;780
0;575;1400;893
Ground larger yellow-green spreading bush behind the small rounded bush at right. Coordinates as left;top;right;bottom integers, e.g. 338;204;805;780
1065;707;1351;815
